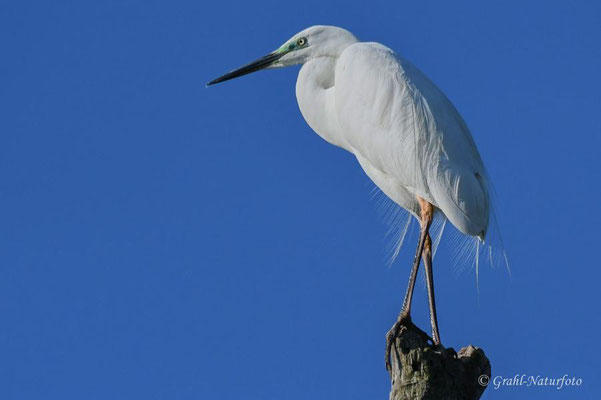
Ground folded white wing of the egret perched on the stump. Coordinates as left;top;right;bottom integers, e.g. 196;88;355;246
335;43;489;238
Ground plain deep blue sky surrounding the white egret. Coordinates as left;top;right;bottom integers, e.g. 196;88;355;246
0;0;601;400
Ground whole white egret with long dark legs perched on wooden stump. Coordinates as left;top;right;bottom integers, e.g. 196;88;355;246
207;26;491;370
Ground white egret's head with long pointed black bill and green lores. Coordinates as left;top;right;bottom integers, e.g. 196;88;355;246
207;25;357;86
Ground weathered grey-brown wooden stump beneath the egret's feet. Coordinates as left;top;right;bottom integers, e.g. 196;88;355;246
390;325;490;400
